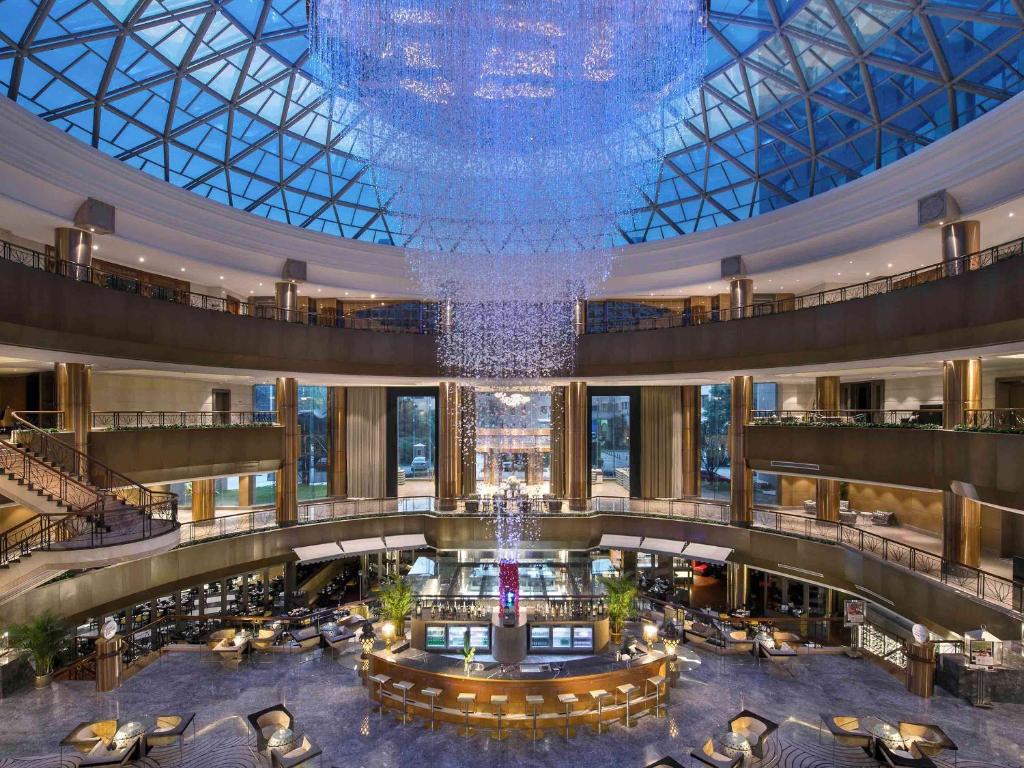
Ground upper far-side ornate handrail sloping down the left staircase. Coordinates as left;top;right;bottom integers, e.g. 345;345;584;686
11;411;178;521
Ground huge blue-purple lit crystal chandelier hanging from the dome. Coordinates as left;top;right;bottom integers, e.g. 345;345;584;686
308;0;707;378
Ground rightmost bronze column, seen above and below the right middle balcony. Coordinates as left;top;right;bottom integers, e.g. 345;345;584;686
942;358;981;568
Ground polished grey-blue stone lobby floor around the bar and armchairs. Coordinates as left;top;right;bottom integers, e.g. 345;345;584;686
0;651;1024;768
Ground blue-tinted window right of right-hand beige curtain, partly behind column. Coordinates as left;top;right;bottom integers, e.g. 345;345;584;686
700;382;778;504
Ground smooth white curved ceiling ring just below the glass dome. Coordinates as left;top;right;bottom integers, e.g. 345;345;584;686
0;95;1024;298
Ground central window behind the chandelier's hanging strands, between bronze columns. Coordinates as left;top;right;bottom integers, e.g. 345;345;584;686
476;390;551;493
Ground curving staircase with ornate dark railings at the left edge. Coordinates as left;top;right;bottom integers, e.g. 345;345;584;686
0;413;178;604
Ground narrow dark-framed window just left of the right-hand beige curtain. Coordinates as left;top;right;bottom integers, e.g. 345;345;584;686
590;394;632;497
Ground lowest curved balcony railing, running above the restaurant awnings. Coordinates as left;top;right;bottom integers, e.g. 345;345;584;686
172;497;1024;617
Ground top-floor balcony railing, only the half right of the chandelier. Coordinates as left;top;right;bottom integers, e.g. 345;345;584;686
586;239;1024;334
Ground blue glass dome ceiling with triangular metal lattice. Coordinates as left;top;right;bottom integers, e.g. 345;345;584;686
0;0;1024;246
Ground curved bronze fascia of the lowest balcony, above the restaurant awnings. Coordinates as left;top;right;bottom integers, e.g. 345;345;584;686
0;513;1020;636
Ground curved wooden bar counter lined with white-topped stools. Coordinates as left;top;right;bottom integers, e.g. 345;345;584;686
367;650;670;733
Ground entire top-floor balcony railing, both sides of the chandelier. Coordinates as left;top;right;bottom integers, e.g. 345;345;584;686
0;239;1024;334
